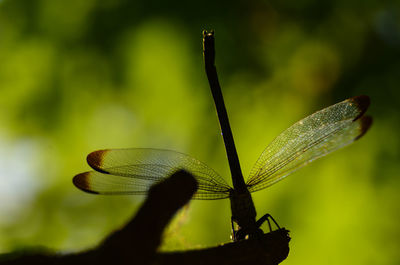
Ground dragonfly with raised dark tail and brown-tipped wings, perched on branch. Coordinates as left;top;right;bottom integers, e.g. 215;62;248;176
73;31;372;241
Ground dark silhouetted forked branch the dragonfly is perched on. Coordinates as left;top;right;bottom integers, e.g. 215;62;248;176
0;171;290;265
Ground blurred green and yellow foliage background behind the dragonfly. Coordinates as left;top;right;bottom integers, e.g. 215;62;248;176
0;0;400;265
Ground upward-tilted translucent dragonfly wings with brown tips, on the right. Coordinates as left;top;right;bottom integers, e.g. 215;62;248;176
246;96;372;192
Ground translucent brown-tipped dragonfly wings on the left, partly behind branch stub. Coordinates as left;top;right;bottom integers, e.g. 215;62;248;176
73;148;231;199
